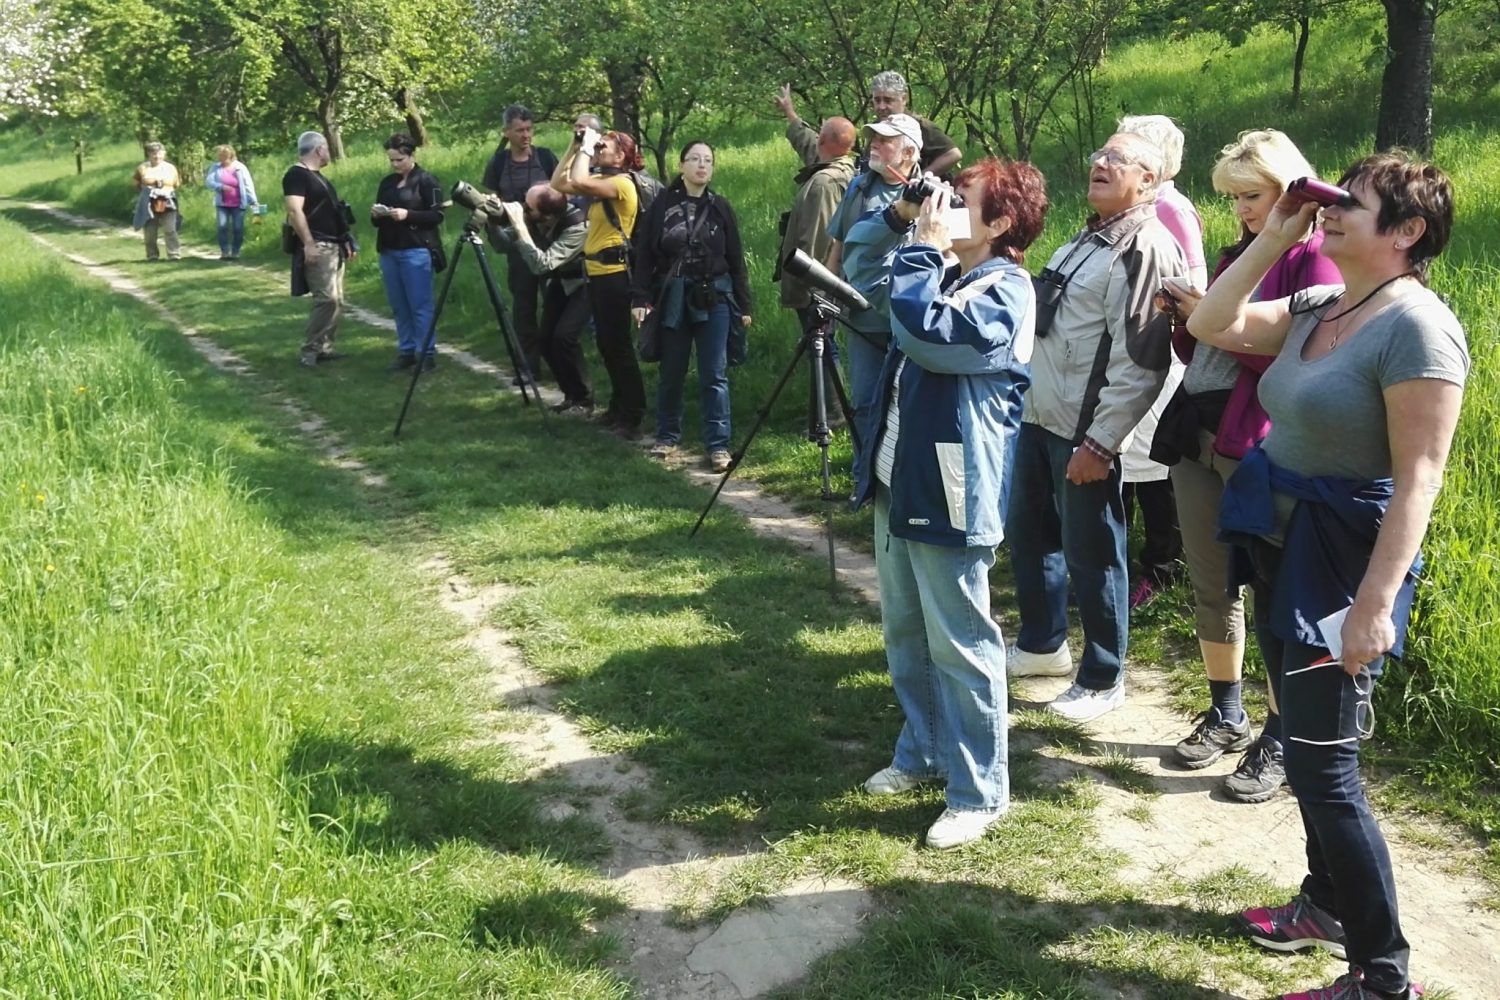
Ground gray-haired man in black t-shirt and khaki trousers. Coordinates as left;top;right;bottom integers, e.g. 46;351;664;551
282;132;354;367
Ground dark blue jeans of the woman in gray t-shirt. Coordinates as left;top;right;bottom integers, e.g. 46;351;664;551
1254;544;1412;994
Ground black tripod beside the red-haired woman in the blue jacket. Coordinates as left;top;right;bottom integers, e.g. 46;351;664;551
689;292;864;589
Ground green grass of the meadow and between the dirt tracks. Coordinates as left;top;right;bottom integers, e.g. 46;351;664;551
0;11;1500;1000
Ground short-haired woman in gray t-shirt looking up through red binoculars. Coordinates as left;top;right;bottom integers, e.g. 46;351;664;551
1188;153;1469;1000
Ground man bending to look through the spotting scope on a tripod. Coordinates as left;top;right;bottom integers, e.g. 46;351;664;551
497;183;594;415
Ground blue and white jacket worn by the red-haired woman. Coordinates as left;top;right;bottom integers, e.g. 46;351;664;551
857;244;1035;547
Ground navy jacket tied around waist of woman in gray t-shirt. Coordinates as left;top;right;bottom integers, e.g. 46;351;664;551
1218;448;1422;673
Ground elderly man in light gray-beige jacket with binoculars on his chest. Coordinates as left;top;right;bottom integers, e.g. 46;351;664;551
1005;133;1187;721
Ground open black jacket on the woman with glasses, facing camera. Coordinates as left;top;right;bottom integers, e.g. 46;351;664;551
630;177;752;316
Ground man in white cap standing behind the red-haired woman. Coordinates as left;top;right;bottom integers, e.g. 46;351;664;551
827;114;923;481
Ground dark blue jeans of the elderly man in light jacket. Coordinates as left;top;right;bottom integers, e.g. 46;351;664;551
1005;423;1130;691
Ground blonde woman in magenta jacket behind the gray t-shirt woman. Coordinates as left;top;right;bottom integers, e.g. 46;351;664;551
1152;129;1341;802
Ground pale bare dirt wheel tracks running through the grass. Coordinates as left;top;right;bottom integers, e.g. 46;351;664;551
14;205;1500;1000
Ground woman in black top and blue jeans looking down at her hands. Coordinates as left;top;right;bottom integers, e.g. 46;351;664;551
371;132;443;370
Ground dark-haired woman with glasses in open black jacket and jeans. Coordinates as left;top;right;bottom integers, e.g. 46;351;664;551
632;141;750;472
